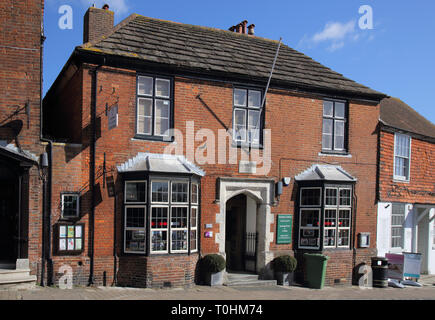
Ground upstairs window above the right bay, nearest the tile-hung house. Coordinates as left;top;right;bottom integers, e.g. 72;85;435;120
322;100;347;153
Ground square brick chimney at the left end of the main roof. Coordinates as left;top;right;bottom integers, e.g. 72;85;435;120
83;4;115;43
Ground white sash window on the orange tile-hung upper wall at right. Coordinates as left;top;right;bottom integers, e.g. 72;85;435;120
394;133;411;180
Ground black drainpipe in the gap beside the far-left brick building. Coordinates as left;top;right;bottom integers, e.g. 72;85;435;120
39;17;53;286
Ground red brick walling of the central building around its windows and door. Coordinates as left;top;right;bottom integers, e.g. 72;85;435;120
46;61;379;286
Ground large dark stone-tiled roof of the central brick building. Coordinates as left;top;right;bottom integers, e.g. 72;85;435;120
77;14;386;99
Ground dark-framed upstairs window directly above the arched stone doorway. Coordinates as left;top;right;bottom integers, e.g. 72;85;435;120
233;88;262;145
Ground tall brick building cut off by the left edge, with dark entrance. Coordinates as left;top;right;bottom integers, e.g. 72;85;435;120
0;0;48;285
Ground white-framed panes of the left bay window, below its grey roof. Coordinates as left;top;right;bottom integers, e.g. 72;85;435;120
124;177;199;254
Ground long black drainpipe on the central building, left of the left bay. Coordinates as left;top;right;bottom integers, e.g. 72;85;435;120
88;57;106;286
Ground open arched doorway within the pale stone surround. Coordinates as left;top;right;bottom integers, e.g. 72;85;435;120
225;194;258;272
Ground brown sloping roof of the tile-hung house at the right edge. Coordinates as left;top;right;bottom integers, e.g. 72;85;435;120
380;98;435;138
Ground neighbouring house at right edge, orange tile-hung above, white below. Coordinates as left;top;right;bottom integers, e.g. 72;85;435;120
377;98;435;274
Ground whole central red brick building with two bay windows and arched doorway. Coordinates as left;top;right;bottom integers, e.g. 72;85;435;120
44;8;385;287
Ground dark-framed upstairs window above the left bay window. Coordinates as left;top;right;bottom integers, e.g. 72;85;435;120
136;76;172;139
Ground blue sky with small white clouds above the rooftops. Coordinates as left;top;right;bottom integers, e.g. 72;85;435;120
43;0;435;123
